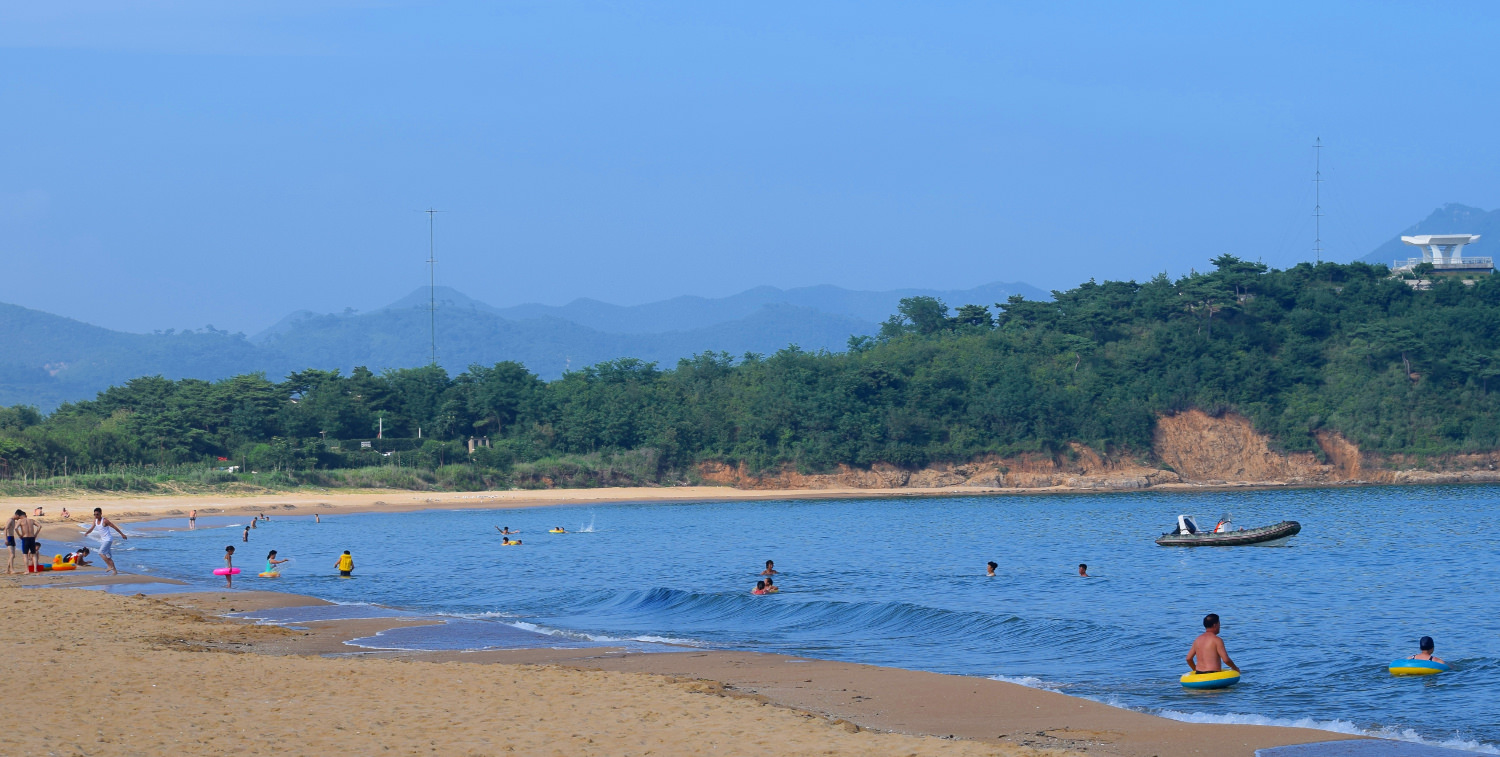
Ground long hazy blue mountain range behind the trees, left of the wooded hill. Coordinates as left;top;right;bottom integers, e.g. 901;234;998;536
0;282;1049;409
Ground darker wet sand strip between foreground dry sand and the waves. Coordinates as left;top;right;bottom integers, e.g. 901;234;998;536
6;571;1368;757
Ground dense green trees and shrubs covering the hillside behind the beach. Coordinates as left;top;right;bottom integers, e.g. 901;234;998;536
0;255;1500;487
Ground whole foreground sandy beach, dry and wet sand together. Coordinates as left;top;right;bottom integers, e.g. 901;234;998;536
0;571;1374;757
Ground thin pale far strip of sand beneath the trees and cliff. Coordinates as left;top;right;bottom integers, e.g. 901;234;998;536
0;480;1500;525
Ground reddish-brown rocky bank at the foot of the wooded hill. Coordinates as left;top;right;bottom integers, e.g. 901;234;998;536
698;409;1500;490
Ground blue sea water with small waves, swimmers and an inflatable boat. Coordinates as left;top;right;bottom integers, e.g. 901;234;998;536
79;486;1500;754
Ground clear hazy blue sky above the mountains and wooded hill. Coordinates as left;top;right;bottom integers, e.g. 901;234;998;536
0;0;1500;331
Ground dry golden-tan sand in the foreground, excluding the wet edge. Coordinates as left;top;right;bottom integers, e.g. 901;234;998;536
0;579;1074;756
